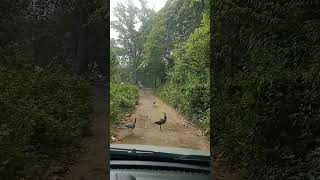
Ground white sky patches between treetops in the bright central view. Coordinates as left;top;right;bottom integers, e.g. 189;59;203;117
110;0;167;39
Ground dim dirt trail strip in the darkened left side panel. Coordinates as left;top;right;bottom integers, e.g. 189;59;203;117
65;82;109;180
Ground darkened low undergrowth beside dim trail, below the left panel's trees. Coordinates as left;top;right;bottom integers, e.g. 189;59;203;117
0;67;92;179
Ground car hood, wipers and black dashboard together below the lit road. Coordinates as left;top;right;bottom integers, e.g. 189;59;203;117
110;148;210;180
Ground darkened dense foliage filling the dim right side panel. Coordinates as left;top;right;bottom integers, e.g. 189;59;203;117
211;0;320;179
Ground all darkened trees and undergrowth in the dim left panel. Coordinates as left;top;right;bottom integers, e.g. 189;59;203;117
0;0;108;179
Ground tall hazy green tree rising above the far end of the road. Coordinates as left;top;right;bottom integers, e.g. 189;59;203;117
140;0;205;88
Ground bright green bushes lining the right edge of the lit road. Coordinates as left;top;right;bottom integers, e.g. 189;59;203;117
157;10;210;129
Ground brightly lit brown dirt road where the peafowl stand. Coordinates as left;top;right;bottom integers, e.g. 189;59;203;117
111;89;209;151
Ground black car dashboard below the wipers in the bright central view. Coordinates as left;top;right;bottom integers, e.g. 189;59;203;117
110;160;210;180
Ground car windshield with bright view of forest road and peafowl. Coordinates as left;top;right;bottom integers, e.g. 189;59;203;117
110;0;210;163
